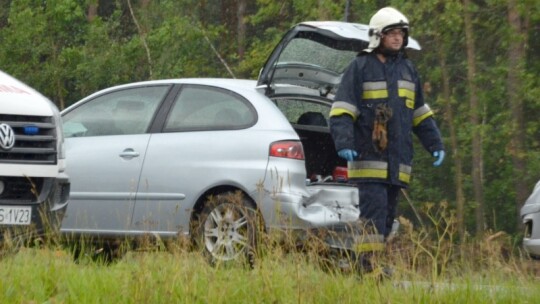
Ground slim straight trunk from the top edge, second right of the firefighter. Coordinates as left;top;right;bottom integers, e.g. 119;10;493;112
463;0;485;236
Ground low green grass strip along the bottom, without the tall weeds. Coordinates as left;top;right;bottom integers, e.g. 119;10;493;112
0;235;540;303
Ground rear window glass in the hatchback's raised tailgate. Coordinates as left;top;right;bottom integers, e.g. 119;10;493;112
277;38;357;74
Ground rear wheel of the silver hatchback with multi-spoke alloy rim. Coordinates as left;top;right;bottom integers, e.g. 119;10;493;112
192;192;260;267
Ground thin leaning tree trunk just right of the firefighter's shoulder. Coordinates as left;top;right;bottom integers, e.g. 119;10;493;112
435;36;465;240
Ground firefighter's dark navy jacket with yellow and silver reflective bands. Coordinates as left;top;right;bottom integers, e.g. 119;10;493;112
330;52;444;187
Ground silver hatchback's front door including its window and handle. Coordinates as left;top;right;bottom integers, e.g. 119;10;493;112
62;85;170;234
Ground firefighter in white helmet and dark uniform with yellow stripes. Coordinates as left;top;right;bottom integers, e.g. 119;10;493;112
330;7;445;237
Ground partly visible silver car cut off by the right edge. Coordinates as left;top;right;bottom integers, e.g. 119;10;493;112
520;181;540;258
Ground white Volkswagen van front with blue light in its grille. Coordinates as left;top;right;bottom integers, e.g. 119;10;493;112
0;71;70;242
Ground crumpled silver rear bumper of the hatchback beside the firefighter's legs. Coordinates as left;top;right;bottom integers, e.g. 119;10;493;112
263;183;385;253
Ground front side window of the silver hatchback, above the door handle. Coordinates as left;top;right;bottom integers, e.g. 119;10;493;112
62;86;169;137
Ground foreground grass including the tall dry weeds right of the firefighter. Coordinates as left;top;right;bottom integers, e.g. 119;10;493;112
0;204;540;303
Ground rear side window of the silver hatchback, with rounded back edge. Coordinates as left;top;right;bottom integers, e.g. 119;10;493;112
164;85;256;132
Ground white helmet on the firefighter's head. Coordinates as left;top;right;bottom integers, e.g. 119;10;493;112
366;7;409;51
